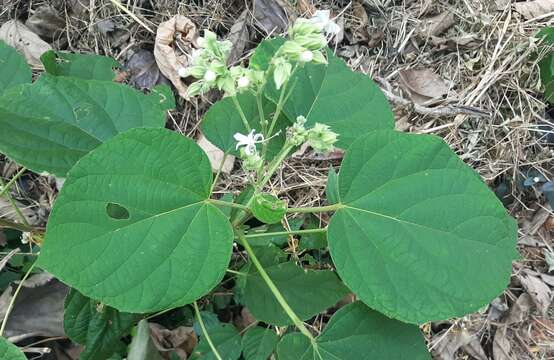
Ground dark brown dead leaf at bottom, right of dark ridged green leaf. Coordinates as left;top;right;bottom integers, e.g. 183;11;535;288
148;323;198;360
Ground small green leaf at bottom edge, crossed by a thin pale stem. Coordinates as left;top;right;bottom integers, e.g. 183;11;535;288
191;324;242;360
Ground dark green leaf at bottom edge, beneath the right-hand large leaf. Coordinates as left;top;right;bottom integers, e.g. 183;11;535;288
277;302;431;360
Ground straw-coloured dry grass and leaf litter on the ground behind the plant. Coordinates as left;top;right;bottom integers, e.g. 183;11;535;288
0;0;554;360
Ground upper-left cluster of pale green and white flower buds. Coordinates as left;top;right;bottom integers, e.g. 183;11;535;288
179;30;264;96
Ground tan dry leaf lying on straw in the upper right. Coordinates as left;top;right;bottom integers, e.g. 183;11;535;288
398;69;450;105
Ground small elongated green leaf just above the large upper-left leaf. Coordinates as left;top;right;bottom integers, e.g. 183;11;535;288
40;50;121;81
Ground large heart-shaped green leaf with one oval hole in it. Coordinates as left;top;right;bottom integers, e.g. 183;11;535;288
39;129;233;313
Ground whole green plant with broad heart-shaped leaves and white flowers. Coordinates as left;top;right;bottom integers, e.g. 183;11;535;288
0;12;516;360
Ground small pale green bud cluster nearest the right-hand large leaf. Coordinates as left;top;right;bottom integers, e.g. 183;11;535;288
288;116;338;154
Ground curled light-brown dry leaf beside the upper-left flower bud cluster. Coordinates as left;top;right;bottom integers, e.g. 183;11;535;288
154;15;198;100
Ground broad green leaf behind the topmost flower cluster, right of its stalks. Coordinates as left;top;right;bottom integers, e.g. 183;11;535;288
251;38;394;148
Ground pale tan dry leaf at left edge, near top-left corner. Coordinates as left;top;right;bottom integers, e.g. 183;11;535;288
0;20;52;70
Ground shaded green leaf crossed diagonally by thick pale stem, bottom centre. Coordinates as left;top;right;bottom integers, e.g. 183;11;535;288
244;261;348;326
